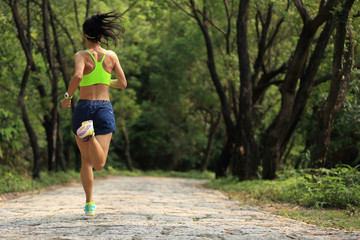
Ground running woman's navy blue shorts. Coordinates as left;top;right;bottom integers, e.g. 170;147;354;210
71;99;116;135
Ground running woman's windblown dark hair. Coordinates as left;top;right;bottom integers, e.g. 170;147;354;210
83;12;125;45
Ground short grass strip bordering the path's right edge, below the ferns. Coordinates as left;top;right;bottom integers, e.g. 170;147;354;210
205;177;360;231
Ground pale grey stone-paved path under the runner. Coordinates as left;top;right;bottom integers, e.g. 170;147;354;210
0;177;360;240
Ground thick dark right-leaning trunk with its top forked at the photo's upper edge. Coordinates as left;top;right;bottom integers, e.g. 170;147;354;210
261;0;339;179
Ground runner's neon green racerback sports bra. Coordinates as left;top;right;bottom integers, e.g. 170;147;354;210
80;50;111;87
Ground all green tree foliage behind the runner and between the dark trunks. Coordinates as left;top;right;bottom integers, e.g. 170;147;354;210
0;0;360;178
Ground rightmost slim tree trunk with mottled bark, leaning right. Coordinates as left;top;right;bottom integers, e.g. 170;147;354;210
311;0;354;167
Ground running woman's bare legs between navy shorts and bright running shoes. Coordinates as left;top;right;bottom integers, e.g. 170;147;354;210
75;133;112;202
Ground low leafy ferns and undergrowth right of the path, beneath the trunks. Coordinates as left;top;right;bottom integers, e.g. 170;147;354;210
209;166;360;208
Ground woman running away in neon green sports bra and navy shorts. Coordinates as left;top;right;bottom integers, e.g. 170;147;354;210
61;12;127;216
